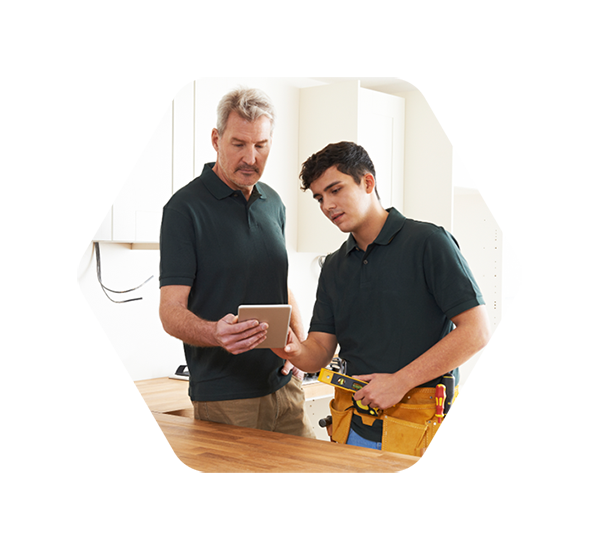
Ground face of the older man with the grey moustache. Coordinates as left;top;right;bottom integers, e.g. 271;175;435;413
212;112;272;199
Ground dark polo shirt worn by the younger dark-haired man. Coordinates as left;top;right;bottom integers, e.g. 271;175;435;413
310;208;485;437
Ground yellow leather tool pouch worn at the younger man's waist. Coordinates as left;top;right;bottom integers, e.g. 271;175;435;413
330;388;444;456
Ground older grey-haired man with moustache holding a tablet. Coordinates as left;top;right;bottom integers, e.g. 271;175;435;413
160;89;314;437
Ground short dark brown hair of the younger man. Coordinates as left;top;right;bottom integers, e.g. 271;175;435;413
300;141;378;196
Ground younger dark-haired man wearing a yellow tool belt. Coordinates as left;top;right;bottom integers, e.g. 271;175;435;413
275;142;488;454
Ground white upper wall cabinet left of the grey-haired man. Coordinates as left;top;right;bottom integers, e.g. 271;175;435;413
93;82;194;244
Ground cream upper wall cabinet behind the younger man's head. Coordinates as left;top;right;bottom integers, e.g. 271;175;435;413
298;82;405;254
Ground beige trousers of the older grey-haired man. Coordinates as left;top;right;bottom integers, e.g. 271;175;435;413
193;376;316;439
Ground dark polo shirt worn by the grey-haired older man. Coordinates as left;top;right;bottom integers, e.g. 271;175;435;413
160;163;291;401
